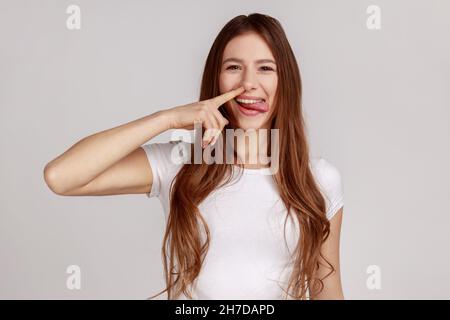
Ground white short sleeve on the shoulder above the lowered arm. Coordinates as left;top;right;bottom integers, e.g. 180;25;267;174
316;158;344;220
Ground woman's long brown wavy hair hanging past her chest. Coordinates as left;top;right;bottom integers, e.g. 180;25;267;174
151;13;335;299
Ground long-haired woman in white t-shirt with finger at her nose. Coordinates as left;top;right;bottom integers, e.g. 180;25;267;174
44;14;344;299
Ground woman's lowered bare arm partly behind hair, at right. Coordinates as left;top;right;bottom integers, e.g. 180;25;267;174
314;207;344;300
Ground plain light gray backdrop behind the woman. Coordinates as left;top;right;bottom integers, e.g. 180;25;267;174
0;0;450;299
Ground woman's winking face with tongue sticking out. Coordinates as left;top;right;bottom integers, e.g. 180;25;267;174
219;32;278;130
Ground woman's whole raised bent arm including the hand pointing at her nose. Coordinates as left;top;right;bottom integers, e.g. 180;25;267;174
44;87;244;196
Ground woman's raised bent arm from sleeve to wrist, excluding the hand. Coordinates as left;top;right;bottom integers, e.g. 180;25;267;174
44;111;170;195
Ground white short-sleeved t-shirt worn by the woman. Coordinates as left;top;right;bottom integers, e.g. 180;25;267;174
143;141;344;300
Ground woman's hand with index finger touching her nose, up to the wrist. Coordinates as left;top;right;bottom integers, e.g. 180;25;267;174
164;87;245;147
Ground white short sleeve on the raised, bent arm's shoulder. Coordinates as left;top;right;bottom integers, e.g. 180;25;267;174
142;141;185;198
